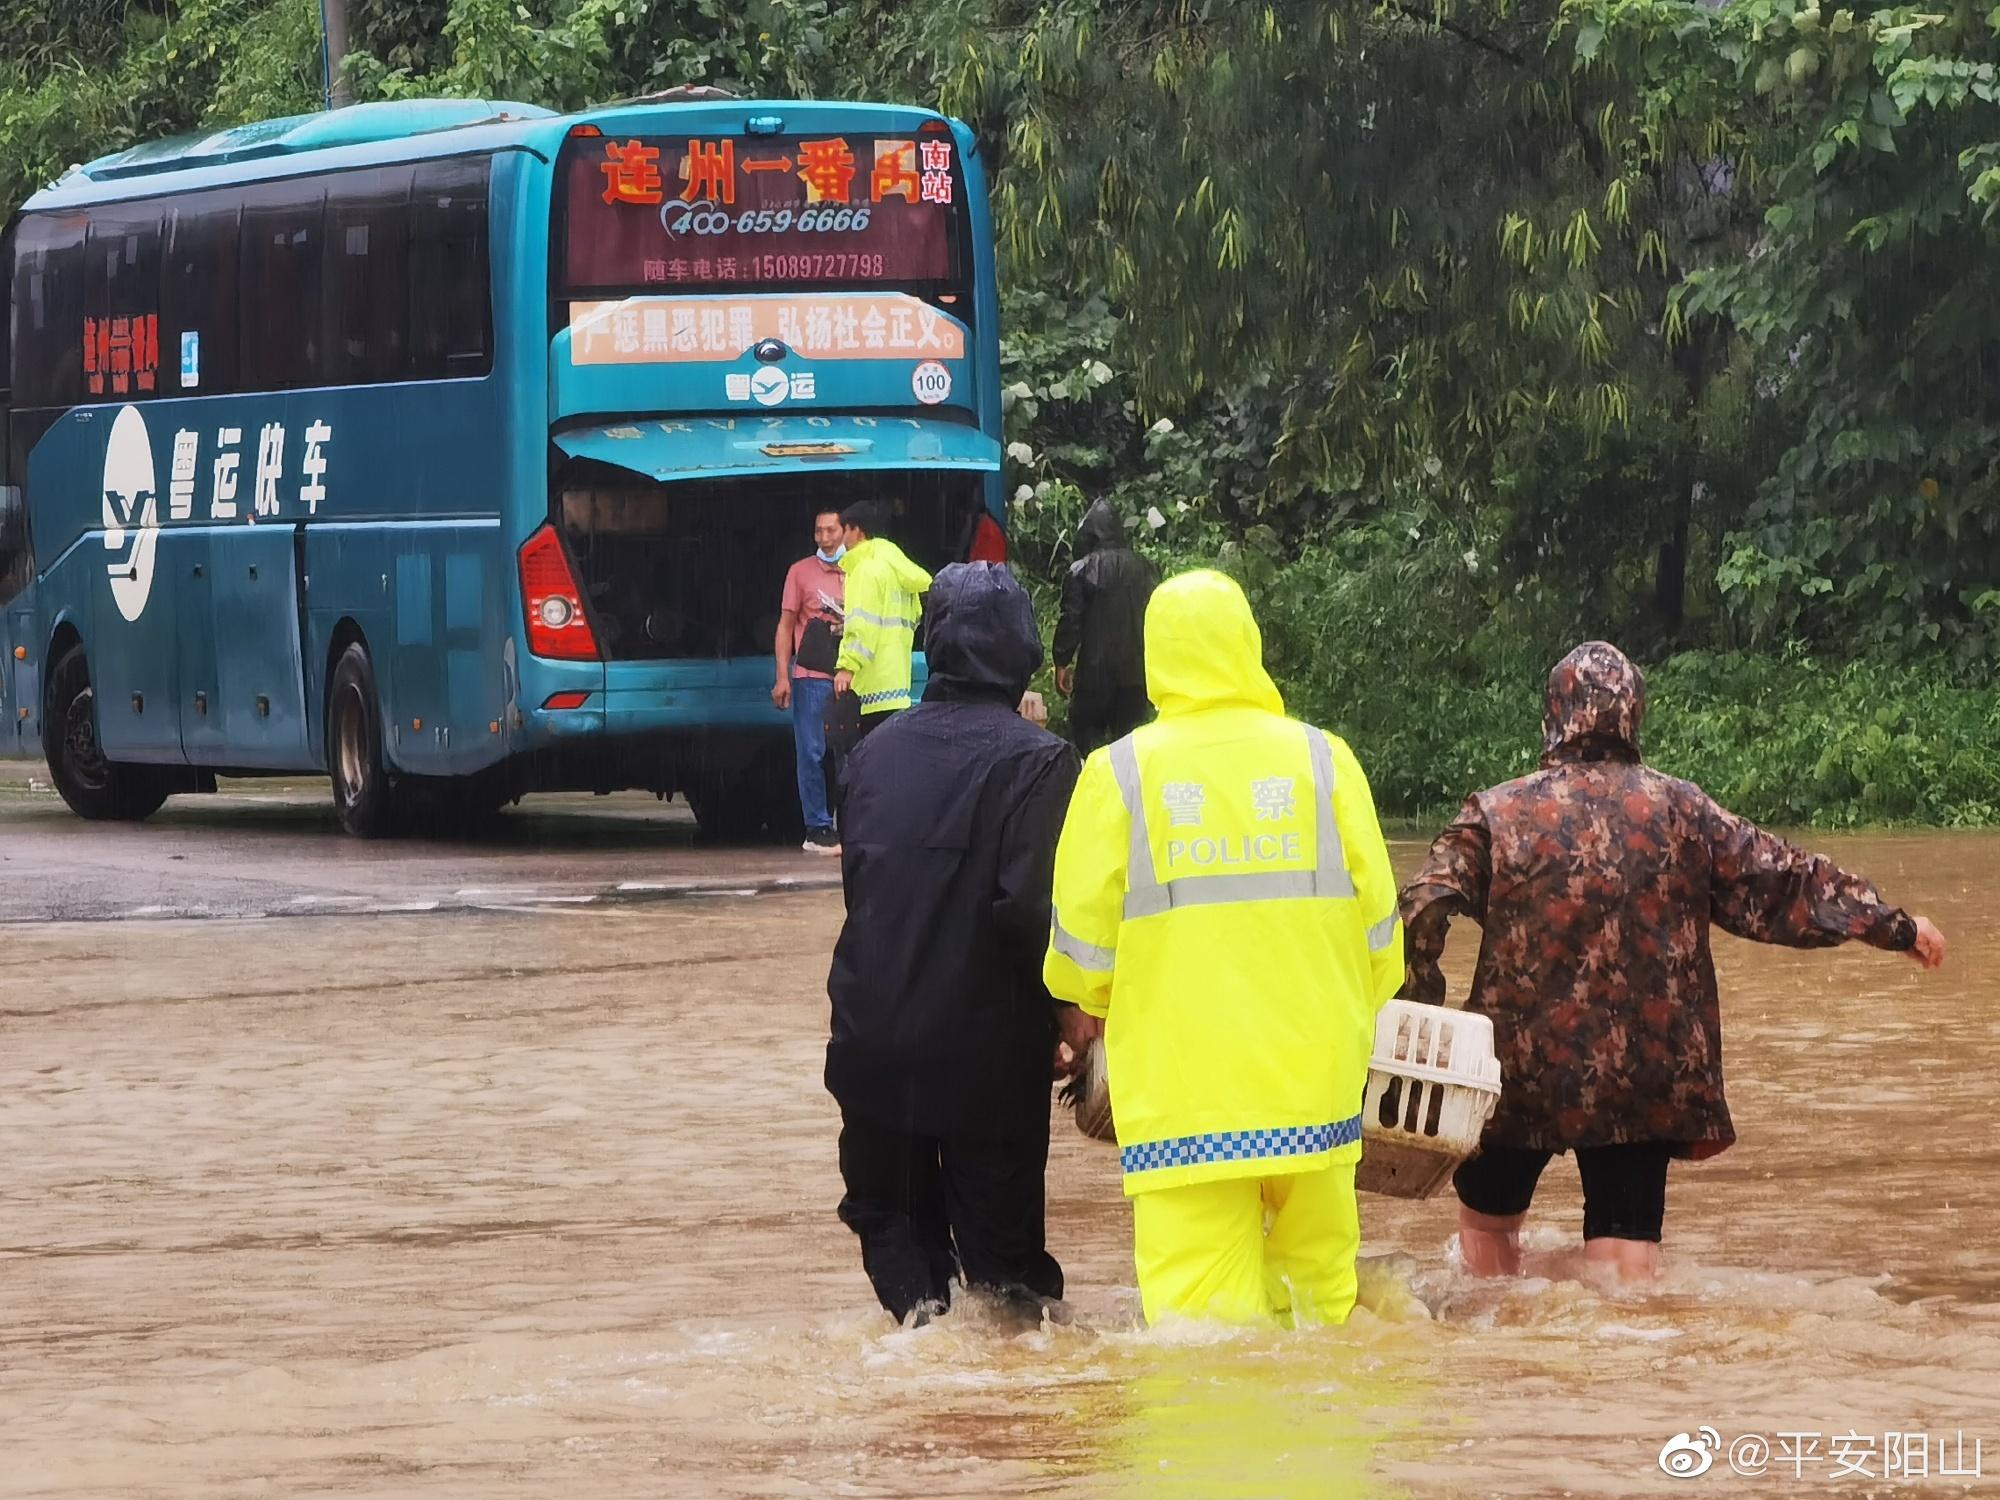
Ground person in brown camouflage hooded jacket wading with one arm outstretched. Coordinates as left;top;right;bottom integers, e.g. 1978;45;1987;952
1402;642;1944;1278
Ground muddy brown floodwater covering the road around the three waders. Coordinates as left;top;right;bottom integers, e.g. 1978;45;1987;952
0;836;2000;1500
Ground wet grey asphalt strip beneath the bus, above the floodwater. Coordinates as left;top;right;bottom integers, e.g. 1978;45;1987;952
0;762;840;922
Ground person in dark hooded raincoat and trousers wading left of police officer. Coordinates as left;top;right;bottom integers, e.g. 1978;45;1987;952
826;562;1082;1322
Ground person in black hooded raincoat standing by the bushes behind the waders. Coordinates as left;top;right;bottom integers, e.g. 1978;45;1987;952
1052;500;1160;756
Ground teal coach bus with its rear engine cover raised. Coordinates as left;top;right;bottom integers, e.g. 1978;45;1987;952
0;90;1006;836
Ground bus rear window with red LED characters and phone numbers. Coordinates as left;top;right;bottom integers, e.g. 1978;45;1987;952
562;132;968;292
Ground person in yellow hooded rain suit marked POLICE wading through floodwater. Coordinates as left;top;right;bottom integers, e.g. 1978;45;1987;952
1044;572;1402;1324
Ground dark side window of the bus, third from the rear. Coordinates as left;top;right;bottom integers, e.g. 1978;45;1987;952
238;178;326;390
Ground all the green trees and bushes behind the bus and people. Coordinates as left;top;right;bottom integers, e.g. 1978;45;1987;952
0;0;2000;822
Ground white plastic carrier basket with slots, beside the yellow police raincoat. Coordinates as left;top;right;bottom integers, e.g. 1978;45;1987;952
1354;1000;1500;1198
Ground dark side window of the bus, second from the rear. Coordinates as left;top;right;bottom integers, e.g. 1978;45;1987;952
326;166;410;386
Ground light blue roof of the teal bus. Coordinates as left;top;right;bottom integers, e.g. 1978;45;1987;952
22;88;968;210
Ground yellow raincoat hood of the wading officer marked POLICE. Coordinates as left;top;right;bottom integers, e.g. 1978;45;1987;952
1146;570;1284;716
